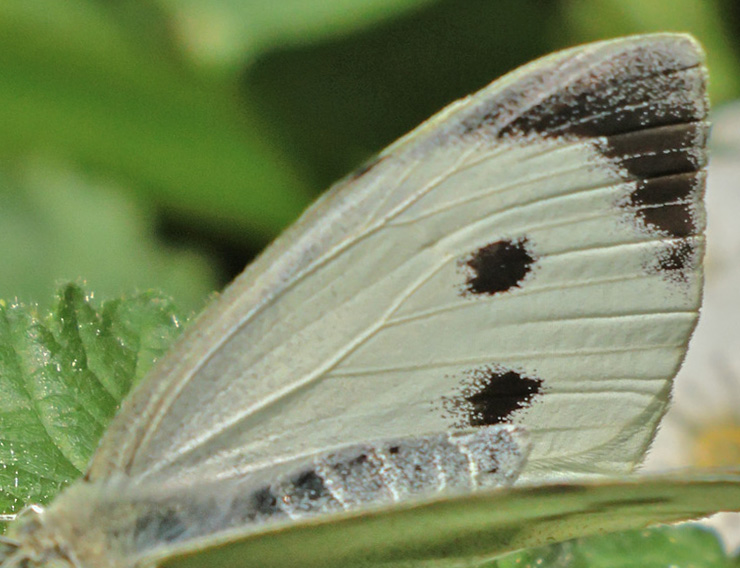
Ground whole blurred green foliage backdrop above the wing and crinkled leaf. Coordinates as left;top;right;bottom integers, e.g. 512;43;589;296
0;0;740;311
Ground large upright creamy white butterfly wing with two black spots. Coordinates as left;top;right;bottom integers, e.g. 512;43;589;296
88;34;708;488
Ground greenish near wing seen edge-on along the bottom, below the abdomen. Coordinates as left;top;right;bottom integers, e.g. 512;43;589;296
146;475;740;568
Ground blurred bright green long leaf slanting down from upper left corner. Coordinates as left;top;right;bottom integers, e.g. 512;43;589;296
0;0;316;238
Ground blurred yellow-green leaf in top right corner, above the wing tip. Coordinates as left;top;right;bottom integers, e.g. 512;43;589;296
563;0;740;103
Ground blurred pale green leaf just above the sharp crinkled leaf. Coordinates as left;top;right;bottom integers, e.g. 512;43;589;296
0;162;217;311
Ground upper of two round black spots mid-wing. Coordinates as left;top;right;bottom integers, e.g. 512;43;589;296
460;238;535;296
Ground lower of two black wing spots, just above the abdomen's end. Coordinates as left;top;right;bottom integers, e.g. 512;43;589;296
443;365;543;427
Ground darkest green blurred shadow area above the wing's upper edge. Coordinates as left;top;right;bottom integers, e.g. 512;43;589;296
242;0;562;187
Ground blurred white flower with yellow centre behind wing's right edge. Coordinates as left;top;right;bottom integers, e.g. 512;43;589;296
644;103;740;551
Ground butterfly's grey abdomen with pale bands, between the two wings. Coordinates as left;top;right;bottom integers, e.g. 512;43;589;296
133;424;529;552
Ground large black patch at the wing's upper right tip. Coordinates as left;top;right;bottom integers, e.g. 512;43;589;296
456;38;709;293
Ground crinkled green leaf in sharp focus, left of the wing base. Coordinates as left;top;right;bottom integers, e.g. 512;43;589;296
0;285;181;513
